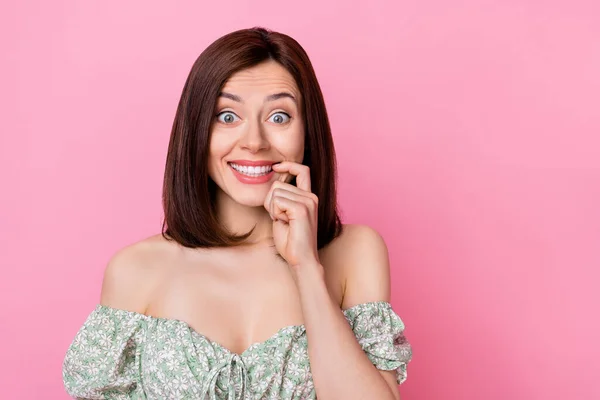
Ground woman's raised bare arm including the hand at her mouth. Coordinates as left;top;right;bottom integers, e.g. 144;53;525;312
264;161;408;400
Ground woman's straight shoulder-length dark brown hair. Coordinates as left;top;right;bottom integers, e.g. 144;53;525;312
162;27;342;248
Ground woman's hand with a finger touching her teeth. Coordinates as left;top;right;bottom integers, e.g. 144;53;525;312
264;161;319;267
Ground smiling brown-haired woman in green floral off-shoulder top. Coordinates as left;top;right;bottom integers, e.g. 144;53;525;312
63;28;411;400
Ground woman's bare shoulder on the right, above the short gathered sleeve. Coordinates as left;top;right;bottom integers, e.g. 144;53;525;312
322;224;391;308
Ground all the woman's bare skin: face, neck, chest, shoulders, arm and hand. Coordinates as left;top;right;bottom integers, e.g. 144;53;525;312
100;61;400;400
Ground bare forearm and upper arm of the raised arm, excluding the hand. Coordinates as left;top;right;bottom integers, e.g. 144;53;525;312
293;225;400;400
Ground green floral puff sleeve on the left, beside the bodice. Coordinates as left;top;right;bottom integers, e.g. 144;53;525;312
62;305;146;400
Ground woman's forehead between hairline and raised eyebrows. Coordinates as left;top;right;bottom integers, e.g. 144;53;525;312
222;60;300;98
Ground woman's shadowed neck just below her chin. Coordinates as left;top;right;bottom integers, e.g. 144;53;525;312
216;190;273;244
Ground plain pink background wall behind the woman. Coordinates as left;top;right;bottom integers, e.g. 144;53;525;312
0;0;600;400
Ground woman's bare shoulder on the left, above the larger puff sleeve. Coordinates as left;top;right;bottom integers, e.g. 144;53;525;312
100;234;173;313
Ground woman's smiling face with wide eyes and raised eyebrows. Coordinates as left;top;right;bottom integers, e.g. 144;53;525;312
208;61;304;207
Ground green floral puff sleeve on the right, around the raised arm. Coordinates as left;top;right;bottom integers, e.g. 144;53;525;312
344;301;412;384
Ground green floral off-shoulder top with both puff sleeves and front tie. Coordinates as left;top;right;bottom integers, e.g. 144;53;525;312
63;301;412;400
